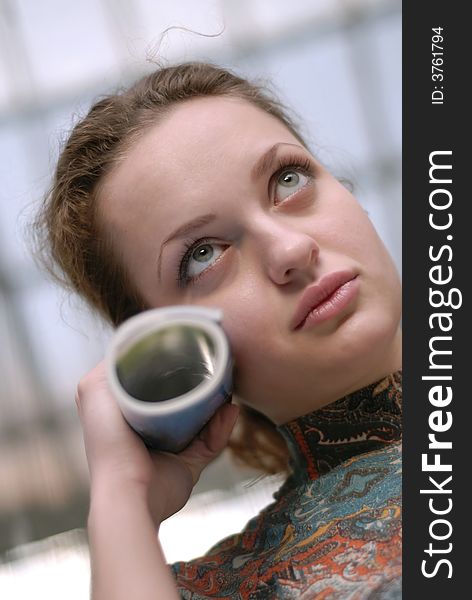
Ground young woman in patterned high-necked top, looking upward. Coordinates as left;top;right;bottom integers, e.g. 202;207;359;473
37;63;401;600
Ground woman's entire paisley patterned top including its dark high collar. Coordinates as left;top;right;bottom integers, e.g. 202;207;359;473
172;372;402;600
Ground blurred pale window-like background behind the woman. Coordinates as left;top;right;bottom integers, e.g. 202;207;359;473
0;0;402;600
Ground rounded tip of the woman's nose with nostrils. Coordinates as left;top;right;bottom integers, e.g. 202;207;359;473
263;220;320;285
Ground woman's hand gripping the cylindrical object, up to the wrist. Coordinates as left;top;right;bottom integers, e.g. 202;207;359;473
76;361;238;526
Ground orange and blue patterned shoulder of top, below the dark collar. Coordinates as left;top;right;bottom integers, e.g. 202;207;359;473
172;444;401;600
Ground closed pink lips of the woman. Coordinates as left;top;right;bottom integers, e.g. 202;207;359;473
292;271;359;329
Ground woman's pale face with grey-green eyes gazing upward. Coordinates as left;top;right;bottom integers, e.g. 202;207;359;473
99;97;401;423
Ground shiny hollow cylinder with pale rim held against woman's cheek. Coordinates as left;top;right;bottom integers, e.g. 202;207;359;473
106;305;233;452
